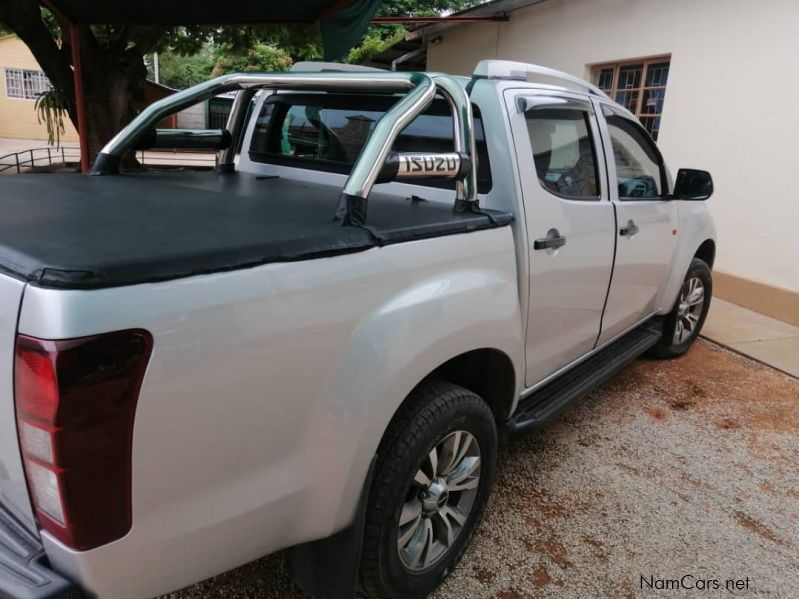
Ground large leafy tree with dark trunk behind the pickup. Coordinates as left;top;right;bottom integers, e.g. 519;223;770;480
0;0;480;153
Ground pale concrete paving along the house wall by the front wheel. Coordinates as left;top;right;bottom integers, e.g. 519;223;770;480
702;298;799;377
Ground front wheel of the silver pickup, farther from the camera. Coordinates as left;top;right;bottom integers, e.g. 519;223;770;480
649;258;713;358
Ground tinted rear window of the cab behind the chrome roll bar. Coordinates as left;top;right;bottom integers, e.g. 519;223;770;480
250;94;491;193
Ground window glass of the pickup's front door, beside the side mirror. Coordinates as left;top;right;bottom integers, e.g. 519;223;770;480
605;113;664;200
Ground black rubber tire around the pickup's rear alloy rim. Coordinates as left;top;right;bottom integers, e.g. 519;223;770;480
361;381;497;599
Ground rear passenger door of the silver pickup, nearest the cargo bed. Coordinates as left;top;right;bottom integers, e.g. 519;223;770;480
506;90;615;386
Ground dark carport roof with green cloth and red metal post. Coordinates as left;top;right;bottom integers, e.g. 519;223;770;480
41;0;380;173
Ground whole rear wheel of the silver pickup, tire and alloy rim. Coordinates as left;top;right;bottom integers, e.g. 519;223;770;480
361;382;497;599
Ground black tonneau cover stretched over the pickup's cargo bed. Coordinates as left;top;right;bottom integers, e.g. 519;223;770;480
0;172;512;289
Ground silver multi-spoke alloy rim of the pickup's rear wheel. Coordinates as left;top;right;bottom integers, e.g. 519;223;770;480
397;431;481;571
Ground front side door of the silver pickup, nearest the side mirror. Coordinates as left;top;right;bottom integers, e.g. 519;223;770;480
595;100;678;344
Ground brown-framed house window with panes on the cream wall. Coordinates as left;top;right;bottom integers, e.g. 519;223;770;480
591;57;669;139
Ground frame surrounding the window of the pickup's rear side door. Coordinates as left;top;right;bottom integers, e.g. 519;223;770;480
521;96;607;202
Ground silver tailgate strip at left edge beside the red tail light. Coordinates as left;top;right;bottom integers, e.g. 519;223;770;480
0;275;36;532
